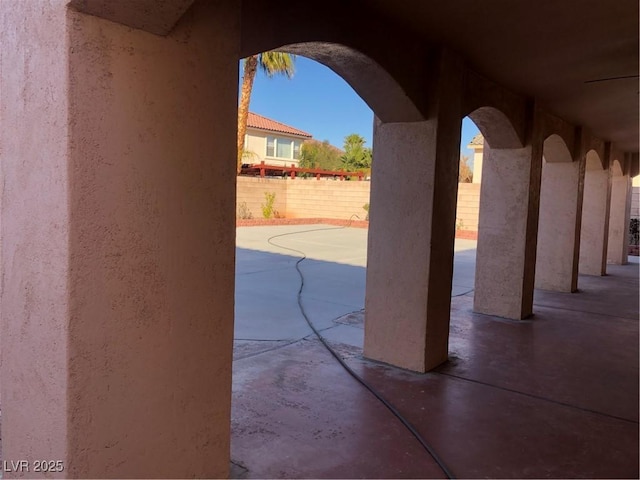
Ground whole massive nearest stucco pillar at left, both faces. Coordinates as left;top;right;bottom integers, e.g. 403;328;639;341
0;0;239;478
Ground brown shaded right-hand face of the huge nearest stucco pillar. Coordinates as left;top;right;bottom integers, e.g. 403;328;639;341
69;0;239;478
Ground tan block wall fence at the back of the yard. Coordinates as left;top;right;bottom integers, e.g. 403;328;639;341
236;177;480;232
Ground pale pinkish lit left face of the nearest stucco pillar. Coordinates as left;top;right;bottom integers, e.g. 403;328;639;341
0;0;71;466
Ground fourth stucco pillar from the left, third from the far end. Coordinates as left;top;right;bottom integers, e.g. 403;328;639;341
535;161;584;292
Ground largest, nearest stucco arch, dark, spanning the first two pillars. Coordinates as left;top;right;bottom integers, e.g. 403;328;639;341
239;0;439;123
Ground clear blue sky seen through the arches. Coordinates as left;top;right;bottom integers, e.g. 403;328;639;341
240;56;478;159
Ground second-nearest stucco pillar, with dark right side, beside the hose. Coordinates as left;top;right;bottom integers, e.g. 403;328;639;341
364;54;461;372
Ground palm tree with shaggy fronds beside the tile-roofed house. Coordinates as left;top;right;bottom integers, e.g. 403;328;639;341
238;51;296;174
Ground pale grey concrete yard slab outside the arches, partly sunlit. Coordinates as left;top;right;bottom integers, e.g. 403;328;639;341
235;225;476;347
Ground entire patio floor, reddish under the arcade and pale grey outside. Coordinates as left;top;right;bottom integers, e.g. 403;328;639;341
231;225;639;478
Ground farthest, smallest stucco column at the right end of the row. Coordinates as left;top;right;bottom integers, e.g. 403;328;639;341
607;175;631;265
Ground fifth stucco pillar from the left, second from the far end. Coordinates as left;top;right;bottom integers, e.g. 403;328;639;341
579;158;611;275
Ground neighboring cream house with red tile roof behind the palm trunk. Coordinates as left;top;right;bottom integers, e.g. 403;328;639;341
244;112;311;167
